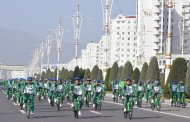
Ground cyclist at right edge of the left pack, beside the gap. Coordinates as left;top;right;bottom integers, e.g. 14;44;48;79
93;80;103;108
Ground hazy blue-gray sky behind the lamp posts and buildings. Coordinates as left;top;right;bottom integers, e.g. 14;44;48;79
0;0;136;65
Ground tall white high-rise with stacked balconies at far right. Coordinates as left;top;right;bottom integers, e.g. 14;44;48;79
137;0;190;67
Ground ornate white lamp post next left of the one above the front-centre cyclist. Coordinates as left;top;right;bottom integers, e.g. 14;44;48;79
55;20;64;80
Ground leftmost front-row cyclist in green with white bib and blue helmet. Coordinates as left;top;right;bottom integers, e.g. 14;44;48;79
23;77;36;115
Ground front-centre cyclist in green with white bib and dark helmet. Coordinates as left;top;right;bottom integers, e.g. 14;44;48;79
71;77;84;116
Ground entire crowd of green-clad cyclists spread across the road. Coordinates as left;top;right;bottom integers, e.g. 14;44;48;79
1;77;187;118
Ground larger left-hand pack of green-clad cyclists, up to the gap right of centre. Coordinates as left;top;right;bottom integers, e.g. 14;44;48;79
4;77;106;116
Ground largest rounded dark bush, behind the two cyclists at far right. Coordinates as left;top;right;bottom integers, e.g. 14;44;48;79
164;58;187;97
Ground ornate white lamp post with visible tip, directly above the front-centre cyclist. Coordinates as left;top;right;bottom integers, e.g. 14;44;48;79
72;4;83;66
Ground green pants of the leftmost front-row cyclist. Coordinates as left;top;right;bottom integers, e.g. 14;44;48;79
24;94;34;112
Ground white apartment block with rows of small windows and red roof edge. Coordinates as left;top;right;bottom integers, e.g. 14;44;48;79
109;14;137;66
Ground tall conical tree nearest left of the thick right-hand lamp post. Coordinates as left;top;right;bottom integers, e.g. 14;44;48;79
146;56;160;81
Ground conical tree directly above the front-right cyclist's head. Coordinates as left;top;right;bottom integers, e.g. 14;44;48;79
120;61;133;80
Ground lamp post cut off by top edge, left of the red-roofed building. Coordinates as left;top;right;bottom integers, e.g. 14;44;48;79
101;0;113;78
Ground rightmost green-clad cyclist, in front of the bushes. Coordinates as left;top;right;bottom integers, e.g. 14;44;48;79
177;81;187;104
